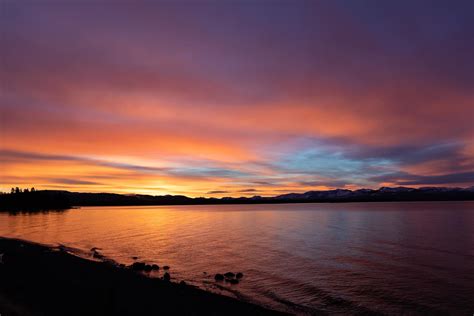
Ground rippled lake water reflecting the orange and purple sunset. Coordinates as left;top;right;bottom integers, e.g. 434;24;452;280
0;202;474;315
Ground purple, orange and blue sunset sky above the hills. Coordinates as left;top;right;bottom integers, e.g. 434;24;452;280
0;0;474;197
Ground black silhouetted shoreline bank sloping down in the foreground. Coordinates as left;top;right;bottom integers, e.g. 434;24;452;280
0;237;286;316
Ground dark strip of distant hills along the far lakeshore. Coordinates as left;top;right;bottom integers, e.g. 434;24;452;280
0;187;474;211
